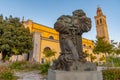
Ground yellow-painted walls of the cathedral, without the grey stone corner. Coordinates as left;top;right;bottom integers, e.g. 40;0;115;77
23;20;94;62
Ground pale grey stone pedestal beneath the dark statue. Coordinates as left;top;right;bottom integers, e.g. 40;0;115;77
48;70;103;80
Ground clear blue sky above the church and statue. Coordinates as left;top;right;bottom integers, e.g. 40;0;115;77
0;0;120;42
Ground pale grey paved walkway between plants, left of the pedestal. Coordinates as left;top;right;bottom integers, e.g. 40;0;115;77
15;71;46;80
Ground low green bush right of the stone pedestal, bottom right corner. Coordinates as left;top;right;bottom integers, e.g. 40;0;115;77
103;68;120;80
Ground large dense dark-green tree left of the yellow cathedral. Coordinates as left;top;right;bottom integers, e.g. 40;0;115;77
0;15;32;60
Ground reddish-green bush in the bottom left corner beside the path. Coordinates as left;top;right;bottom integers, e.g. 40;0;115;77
0;66;17;80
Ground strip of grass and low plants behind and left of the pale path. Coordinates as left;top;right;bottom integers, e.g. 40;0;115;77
0;61;50;80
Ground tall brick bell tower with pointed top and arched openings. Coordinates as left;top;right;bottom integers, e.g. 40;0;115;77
94;7;109;42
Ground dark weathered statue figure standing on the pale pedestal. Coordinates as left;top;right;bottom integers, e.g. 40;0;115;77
51;9;96;71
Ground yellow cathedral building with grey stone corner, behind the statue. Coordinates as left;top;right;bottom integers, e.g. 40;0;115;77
23;20;94;63
